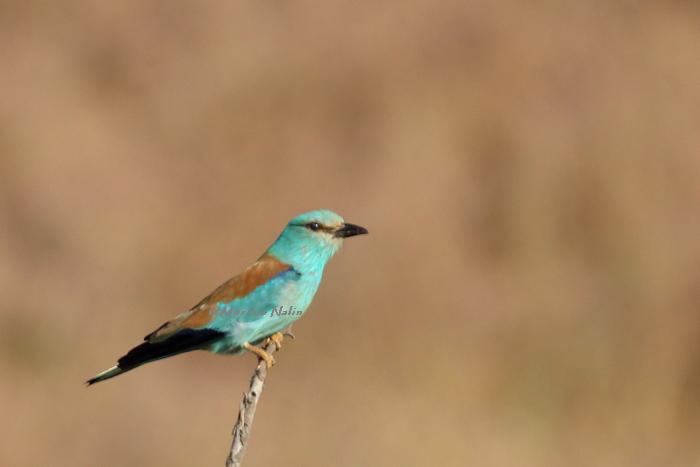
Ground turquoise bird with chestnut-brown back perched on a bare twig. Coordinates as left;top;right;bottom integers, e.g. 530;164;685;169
87;209;368;385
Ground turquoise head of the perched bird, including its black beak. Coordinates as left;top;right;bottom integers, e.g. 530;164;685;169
268;209;368;272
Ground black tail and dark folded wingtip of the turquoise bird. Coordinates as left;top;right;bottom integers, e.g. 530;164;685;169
86;329;225;386
